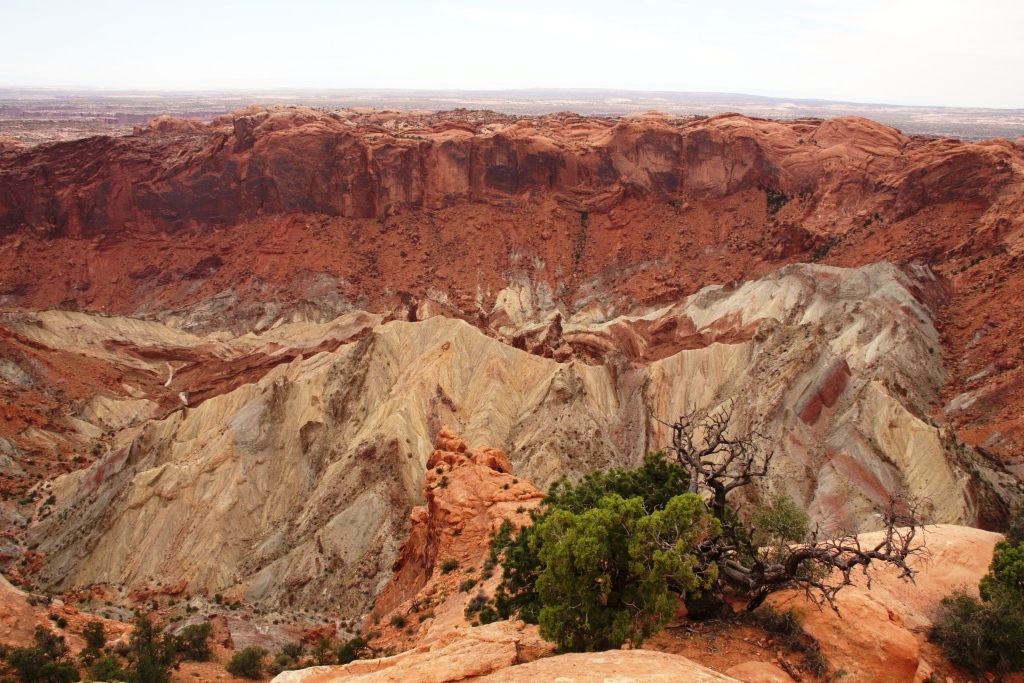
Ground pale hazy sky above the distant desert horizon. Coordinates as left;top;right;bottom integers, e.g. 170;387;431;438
0;0;1024;108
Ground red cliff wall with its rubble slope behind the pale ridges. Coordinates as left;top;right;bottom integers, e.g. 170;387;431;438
0;106;1024;468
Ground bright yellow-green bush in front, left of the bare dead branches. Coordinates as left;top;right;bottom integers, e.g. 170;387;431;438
536;494;721;652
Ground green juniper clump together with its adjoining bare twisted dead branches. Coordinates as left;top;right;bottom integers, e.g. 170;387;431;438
483;404;918;651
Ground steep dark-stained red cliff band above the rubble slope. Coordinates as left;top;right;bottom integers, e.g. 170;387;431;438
0;108;1020;238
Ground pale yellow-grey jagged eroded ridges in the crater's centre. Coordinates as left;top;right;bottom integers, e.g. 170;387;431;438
0;258;1018;617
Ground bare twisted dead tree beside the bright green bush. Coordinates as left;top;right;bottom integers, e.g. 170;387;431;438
663;401;923;618
